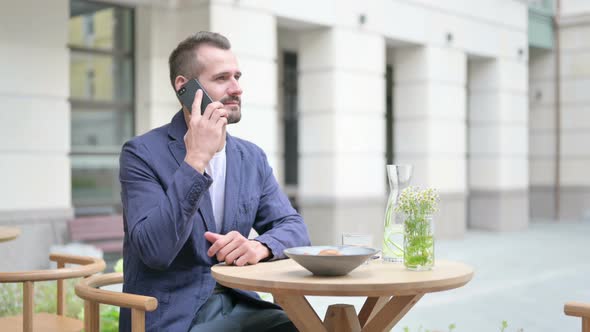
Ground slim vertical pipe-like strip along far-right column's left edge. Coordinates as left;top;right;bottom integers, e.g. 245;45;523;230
553;0;561;221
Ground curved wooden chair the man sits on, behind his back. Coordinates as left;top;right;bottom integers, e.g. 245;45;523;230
76;272;158;332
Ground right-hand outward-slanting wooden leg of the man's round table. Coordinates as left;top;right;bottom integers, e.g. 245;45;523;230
362;294;424;332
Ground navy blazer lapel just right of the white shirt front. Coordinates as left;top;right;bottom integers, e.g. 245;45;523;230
221;134;243;234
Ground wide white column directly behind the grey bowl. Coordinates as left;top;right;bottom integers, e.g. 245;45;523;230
298;28;386;246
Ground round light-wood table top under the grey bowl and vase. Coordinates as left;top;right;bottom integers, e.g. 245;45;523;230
211;259;473;296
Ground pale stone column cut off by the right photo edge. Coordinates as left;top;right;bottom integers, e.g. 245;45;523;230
558;13;590;221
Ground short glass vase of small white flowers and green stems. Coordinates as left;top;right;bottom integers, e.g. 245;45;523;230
396;187;439;269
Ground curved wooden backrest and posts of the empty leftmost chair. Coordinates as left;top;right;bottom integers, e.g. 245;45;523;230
0;254;106;332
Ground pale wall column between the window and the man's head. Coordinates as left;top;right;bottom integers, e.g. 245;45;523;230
135;0;209;135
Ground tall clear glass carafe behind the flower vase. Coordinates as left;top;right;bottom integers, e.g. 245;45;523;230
382;165;412;263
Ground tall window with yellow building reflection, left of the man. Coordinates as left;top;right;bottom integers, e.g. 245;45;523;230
68;0;134;215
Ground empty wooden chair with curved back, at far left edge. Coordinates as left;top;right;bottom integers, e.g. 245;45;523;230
0;254;106;332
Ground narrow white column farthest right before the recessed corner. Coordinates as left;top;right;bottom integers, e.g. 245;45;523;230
469;59;529;231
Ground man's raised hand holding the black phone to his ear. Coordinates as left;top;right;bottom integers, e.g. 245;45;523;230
184;89;227;173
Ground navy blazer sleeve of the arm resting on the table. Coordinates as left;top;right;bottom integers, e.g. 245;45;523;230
253;151;310;260
